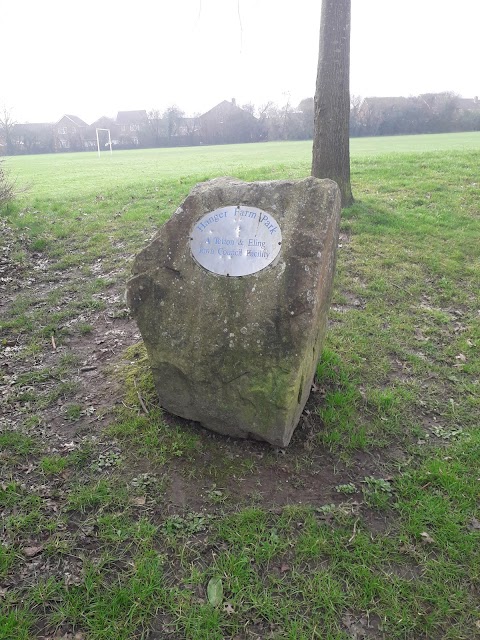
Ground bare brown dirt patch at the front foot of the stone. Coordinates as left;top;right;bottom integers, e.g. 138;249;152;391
151;404;406;524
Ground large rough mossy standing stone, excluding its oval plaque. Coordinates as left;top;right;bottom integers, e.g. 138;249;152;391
127;178;340;447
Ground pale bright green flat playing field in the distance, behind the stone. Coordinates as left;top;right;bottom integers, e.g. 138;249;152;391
6;132;480;199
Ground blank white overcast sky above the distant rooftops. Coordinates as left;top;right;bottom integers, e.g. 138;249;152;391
0;0;480;123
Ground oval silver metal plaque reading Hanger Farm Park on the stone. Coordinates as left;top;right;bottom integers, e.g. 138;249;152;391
190;205;282;276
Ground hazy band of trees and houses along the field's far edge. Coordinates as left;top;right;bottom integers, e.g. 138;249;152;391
0;92;480;155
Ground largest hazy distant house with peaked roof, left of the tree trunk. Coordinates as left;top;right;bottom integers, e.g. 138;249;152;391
197;99;259;144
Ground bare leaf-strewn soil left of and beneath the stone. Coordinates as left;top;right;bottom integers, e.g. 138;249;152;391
0;215;404;529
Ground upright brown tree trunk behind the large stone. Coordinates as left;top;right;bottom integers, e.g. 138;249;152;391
312;0;353;207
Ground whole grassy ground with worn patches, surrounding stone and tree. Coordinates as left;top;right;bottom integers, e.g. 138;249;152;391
0;133;480;640
